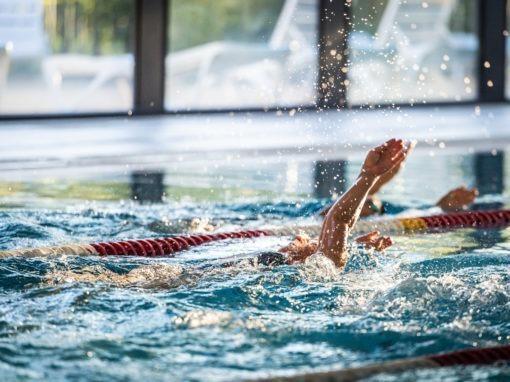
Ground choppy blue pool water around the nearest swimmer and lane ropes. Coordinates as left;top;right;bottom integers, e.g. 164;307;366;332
0;199;510;381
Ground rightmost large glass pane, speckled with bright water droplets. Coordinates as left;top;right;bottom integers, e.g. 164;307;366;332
348;0;478;104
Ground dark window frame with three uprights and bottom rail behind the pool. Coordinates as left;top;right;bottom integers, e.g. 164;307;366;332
0;0;510;120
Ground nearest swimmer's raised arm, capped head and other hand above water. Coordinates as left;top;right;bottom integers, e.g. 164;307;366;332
256;139;409;269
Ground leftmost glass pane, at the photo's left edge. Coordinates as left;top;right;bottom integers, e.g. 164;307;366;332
0;0;135;115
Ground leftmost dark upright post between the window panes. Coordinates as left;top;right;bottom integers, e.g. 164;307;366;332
134;0;169;114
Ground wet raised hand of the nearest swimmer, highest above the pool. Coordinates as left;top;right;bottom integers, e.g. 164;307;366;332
361;139;407;178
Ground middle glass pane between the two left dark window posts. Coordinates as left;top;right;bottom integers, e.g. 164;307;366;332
165;0;318;110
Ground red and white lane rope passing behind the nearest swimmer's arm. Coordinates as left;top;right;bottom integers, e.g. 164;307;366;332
0;210;510;258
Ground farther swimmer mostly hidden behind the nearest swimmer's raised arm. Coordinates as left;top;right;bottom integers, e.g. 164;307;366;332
320;141;478;217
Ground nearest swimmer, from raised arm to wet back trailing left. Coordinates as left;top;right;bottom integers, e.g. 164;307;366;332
52;139;408;285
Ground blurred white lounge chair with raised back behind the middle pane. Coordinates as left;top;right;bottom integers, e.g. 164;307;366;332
166;0;318;106
